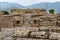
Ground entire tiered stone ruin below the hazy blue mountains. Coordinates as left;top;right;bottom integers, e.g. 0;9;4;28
0;9;60;40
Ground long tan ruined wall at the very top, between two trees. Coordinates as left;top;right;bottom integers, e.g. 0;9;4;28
11;9;47;15
